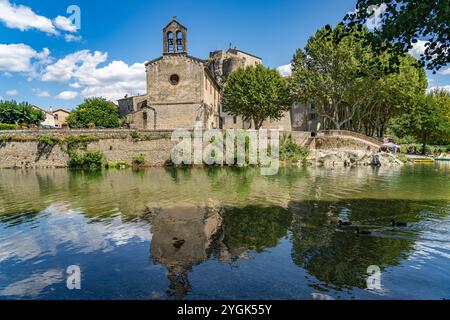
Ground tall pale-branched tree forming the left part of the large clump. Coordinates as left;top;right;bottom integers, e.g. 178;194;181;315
290;24;372;130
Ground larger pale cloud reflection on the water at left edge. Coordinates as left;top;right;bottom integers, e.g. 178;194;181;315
0;206;151;262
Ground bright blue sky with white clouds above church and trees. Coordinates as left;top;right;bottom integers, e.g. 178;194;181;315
0;0;450;109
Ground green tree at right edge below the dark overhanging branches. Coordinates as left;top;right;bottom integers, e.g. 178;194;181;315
391;90;450;154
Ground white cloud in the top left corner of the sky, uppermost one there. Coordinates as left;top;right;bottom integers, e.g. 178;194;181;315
0;0;58;35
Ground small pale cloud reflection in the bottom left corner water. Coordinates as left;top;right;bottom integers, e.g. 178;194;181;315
0;269;63;297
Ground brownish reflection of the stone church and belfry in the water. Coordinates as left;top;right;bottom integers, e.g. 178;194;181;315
151;207;245;298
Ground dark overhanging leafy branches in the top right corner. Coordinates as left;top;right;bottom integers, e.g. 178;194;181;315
346;0;450;69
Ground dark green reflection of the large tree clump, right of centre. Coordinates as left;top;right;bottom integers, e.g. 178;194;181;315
290;199;426;288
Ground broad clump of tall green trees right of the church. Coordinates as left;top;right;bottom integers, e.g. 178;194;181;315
290;24;427;137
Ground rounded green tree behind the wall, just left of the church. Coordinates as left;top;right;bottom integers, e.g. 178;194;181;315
67;98;120;128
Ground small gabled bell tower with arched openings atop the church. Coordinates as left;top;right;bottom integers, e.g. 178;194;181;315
163;17;187;55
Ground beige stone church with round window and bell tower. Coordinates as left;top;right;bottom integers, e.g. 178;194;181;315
118;17;291;130
